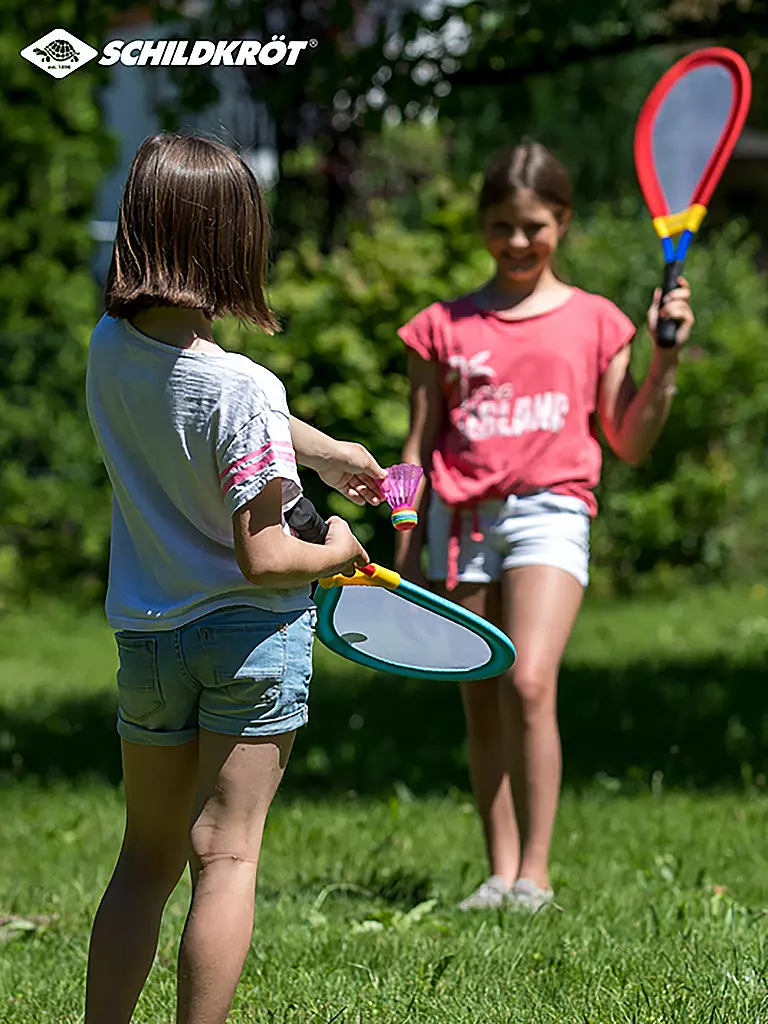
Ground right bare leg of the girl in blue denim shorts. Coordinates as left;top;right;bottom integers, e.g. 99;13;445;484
177;729;295;1024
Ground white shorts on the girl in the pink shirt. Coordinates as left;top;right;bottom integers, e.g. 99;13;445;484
427;490;590;587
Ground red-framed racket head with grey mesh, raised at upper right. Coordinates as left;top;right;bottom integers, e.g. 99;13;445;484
635;46;752;218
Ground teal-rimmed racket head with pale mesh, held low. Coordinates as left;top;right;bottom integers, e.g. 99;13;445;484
315;573;516;682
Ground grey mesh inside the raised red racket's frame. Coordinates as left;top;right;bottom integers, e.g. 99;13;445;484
652;65;733;213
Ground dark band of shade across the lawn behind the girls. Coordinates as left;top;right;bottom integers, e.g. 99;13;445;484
0;657;768;795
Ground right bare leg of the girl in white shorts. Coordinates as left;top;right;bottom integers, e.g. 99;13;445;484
501;565;583;888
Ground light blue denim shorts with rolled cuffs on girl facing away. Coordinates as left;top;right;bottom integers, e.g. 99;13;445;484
115;605;316;746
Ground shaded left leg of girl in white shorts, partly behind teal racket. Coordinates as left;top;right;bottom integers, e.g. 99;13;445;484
441;583;519;885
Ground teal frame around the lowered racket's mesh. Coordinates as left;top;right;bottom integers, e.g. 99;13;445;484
315;579;517;682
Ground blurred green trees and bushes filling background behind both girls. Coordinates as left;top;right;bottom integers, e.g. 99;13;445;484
0;0;768;592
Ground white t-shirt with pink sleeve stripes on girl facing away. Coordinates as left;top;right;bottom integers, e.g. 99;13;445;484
86;316;312;630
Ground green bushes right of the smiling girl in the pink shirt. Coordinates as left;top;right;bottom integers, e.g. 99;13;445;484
563;206;768;585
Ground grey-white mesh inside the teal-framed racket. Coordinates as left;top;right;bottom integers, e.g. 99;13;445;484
333;587;492;672
